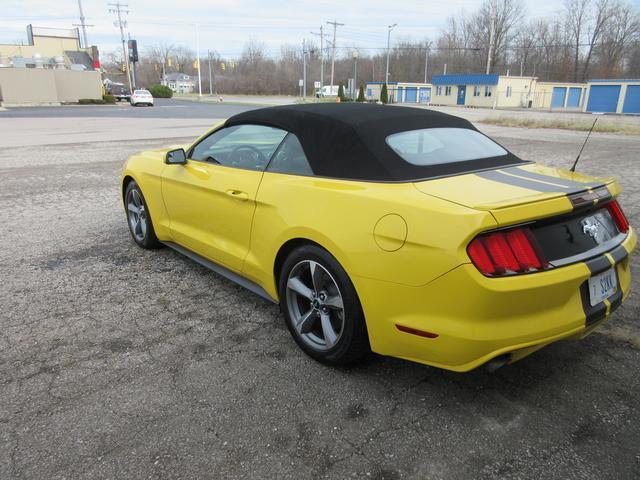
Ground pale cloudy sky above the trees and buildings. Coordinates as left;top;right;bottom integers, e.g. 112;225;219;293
0;0;640;59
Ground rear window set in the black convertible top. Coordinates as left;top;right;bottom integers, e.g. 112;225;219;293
386;128;508;166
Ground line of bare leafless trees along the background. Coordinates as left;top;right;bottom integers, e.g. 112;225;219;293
104;0;640;95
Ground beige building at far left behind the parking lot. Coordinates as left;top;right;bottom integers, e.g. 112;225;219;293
0;25;102;106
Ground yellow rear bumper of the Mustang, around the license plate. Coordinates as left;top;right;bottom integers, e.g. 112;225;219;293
354;226;637;371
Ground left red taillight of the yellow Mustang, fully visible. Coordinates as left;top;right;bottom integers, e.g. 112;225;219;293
467;228;549;277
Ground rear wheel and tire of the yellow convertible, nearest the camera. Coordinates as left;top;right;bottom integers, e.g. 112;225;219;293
278;245;371;365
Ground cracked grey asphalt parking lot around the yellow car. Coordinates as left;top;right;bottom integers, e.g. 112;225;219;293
0;102;640;480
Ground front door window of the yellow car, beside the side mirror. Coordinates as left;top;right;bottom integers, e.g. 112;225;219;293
191;125;287;171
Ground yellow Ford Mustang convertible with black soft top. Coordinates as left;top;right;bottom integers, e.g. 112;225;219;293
122;104;637;371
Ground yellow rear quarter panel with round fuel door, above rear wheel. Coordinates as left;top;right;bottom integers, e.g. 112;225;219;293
243;172;496;298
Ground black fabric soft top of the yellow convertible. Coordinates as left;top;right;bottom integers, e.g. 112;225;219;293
225;103;525;182
